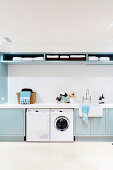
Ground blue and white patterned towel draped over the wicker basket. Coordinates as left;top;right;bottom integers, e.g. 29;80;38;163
20;91;31;104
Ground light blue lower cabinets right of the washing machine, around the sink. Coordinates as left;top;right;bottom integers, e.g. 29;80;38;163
74;109;113;137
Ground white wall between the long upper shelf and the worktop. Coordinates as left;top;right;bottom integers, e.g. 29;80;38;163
8;65;113;103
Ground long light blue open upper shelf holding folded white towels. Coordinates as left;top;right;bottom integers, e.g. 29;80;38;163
0;52;113;65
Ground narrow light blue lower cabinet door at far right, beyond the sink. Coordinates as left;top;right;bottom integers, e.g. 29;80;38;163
106;109;113;135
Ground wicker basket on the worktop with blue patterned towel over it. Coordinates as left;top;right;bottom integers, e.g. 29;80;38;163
16;89;36;104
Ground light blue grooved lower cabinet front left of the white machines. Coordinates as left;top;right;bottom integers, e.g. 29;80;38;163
0;109;25;136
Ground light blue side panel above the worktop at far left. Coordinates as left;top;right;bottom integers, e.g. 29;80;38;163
0;54;8;104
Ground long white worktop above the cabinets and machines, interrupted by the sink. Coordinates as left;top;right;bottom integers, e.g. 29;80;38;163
0;103;113;108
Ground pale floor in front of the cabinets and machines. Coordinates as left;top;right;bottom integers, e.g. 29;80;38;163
0;142;113;170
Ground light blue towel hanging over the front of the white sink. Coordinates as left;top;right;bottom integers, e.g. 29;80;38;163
81;105;90;124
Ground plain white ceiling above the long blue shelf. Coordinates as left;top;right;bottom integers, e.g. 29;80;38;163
0;0;113;45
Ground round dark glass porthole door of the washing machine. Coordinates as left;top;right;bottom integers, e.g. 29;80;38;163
55;116;69;131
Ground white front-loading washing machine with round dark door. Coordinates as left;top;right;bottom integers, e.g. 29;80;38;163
50;109;74;142
